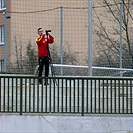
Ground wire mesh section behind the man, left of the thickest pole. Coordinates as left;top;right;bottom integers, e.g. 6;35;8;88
2;0;87;73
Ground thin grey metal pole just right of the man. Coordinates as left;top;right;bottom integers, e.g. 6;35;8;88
60;7;63;75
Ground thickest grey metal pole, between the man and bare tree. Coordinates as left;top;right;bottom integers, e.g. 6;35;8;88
88;0;92;76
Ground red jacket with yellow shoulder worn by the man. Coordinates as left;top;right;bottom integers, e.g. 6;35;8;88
36;36;54;57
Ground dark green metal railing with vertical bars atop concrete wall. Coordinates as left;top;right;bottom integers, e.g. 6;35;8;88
0;76;133;116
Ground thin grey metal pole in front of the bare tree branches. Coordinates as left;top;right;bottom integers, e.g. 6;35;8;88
120;0;123;77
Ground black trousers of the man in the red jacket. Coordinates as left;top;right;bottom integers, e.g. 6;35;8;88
38;56;50;84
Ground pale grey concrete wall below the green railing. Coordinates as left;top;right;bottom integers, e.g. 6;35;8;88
0;115;133;133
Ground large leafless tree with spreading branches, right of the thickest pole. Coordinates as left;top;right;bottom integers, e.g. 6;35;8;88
93;0;133;68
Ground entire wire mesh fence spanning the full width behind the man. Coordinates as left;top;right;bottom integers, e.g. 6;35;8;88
0;0;133;76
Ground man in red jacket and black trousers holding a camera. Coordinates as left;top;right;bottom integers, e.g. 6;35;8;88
36;28;54;85
